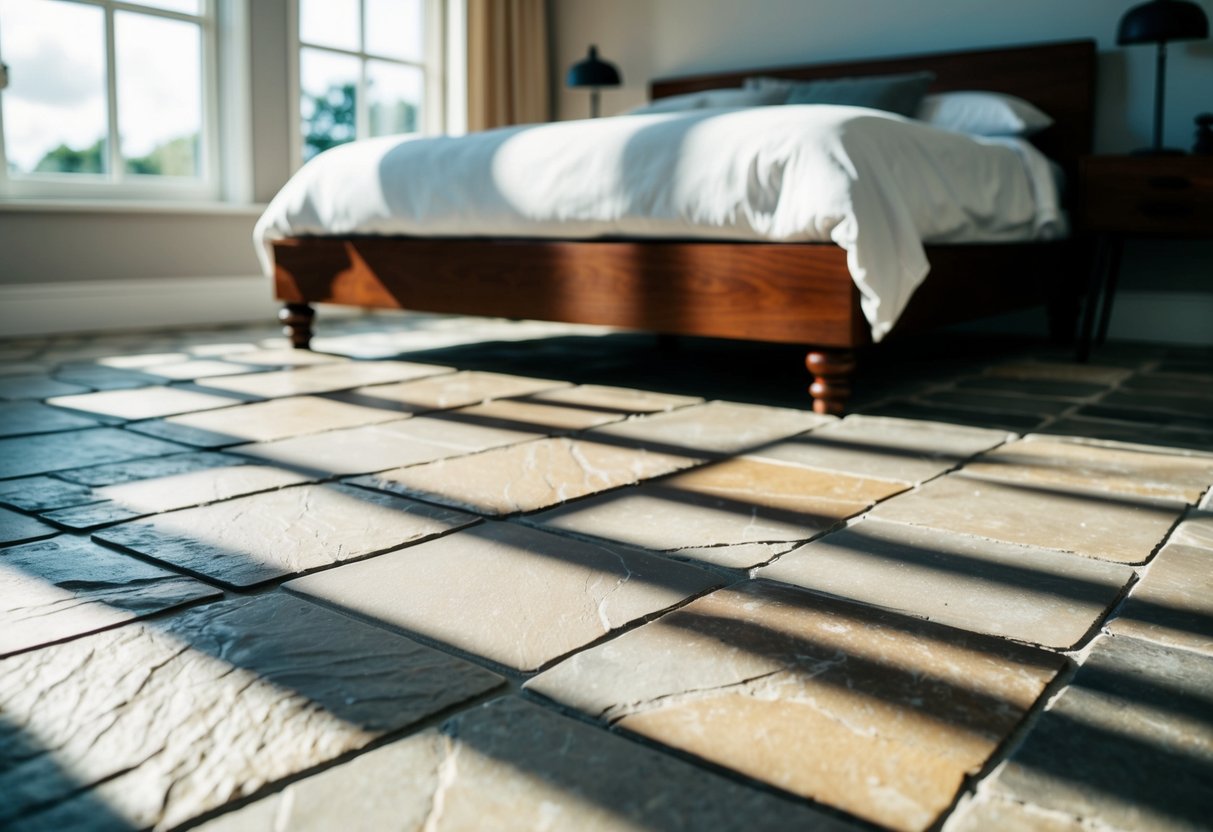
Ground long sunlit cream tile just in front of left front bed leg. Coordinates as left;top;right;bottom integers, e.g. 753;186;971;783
198;361;451;399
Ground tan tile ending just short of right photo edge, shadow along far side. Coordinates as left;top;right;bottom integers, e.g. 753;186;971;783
872;473;1184;564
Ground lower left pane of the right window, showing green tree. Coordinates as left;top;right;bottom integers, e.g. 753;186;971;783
300;49;359;161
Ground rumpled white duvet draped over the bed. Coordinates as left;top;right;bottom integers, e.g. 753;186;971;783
256;104;1064;340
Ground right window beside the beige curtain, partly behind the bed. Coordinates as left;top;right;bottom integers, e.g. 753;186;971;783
296;0;445;161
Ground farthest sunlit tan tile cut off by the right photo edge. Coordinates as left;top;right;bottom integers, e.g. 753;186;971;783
964;437;1213;502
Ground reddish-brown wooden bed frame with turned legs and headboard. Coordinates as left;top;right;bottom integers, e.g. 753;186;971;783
274;40;1095;412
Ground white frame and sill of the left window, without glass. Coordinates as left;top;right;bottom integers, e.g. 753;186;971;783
0;0;252;203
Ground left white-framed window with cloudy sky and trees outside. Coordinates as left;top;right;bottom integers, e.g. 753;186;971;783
0;0;246;199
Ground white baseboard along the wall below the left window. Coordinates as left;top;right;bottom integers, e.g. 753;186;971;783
0;275;312;337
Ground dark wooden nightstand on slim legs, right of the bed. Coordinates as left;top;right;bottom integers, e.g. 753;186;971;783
1076;155;1213;360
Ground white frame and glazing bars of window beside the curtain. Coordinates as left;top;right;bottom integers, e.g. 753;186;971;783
287;0;456;170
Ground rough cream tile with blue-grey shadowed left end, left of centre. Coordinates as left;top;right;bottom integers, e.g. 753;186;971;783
93;485;477;587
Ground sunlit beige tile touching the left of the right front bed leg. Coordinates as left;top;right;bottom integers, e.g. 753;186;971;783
585;401;835;457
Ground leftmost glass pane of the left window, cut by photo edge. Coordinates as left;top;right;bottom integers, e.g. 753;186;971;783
0;0;107;173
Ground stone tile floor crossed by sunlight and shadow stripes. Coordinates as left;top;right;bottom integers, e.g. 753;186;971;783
0;315;1213;832
